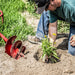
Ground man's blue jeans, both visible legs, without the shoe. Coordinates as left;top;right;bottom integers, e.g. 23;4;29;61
36;11;75;55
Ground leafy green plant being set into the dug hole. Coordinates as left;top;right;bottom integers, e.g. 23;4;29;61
42;38;59;62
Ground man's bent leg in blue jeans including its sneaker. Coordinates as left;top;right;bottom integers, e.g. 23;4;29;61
28;11;49;44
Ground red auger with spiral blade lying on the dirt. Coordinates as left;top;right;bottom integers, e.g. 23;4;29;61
0;33;26;59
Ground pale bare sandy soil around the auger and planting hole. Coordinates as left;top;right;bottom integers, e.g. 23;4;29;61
0;13;75;75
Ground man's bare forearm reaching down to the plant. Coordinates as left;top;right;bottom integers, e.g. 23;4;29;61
49;21;57;43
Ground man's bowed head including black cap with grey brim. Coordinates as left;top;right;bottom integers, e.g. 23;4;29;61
35;0;60;13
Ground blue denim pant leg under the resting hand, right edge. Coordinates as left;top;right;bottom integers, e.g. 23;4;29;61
68;23;75;55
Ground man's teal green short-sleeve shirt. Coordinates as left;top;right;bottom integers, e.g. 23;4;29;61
49;0;75;23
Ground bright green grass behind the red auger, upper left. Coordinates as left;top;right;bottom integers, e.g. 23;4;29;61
0;0;34;44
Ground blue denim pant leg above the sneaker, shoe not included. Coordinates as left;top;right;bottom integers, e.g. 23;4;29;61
36;11;49;39
